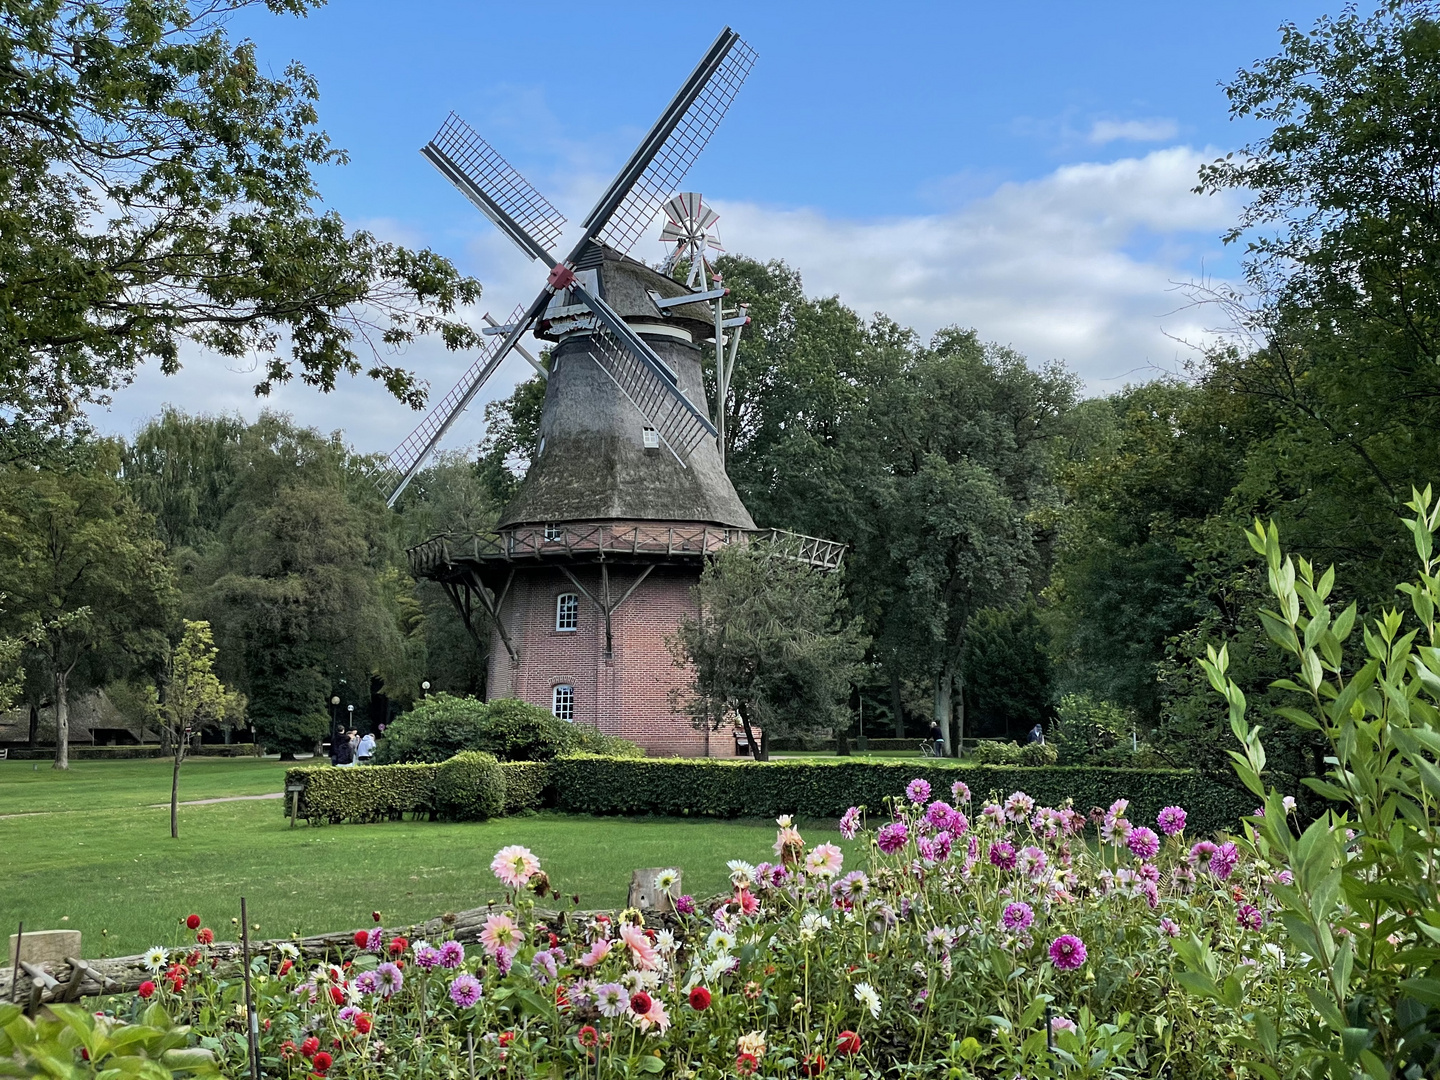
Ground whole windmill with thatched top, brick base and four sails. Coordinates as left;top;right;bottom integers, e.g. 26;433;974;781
394;29;844;755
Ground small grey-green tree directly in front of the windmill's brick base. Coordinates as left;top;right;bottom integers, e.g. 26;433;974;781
670;541;867;759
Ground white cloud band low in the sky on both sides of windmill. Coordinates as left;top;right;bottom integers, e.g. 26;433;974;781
94;147;1237;451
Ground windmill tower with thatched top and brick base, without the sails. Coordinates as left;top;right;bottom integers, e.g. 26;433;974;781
412;252;842;756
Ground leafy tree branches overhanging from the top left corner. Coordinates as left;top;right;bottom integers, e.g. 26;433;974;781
0;0;480;429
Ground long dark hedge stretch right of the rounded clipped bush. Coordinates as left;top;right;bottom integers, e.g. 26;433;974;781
550;755;1256;835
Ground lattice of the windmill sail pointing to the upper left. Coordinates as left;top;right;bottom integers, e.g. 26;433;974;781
425;112;564;259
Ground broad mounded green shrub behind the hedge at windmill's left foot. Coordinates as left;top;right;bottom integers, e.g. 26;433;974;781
374;694;644;765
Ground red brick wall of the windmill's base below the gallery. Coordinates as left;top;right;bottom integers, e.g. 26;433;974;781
488;567;734;757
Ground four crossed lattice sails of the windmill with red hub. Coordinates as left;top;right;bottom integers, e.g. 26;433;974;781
374;27;755;505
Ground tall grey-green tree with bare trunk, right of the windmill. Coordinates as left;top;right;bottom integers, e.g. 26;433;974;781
851;328;1076;752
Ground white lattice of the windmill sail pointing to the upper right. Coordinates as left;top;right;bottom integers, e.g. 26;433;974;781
586;36;756;262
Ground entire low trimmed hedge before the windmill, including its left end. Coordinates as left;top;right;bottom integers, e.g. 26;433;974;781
285;753;1254;834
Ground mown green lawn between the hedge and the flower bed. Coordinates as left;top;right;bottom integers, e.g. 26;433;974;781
0;759;838;956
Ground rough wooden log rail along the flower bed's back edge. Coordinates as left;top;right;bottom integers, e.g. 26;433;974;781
0;897;694;1014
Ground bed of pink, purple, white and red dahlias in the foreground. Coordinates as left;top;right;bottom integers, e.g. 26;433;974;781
121;770;1308;1080
